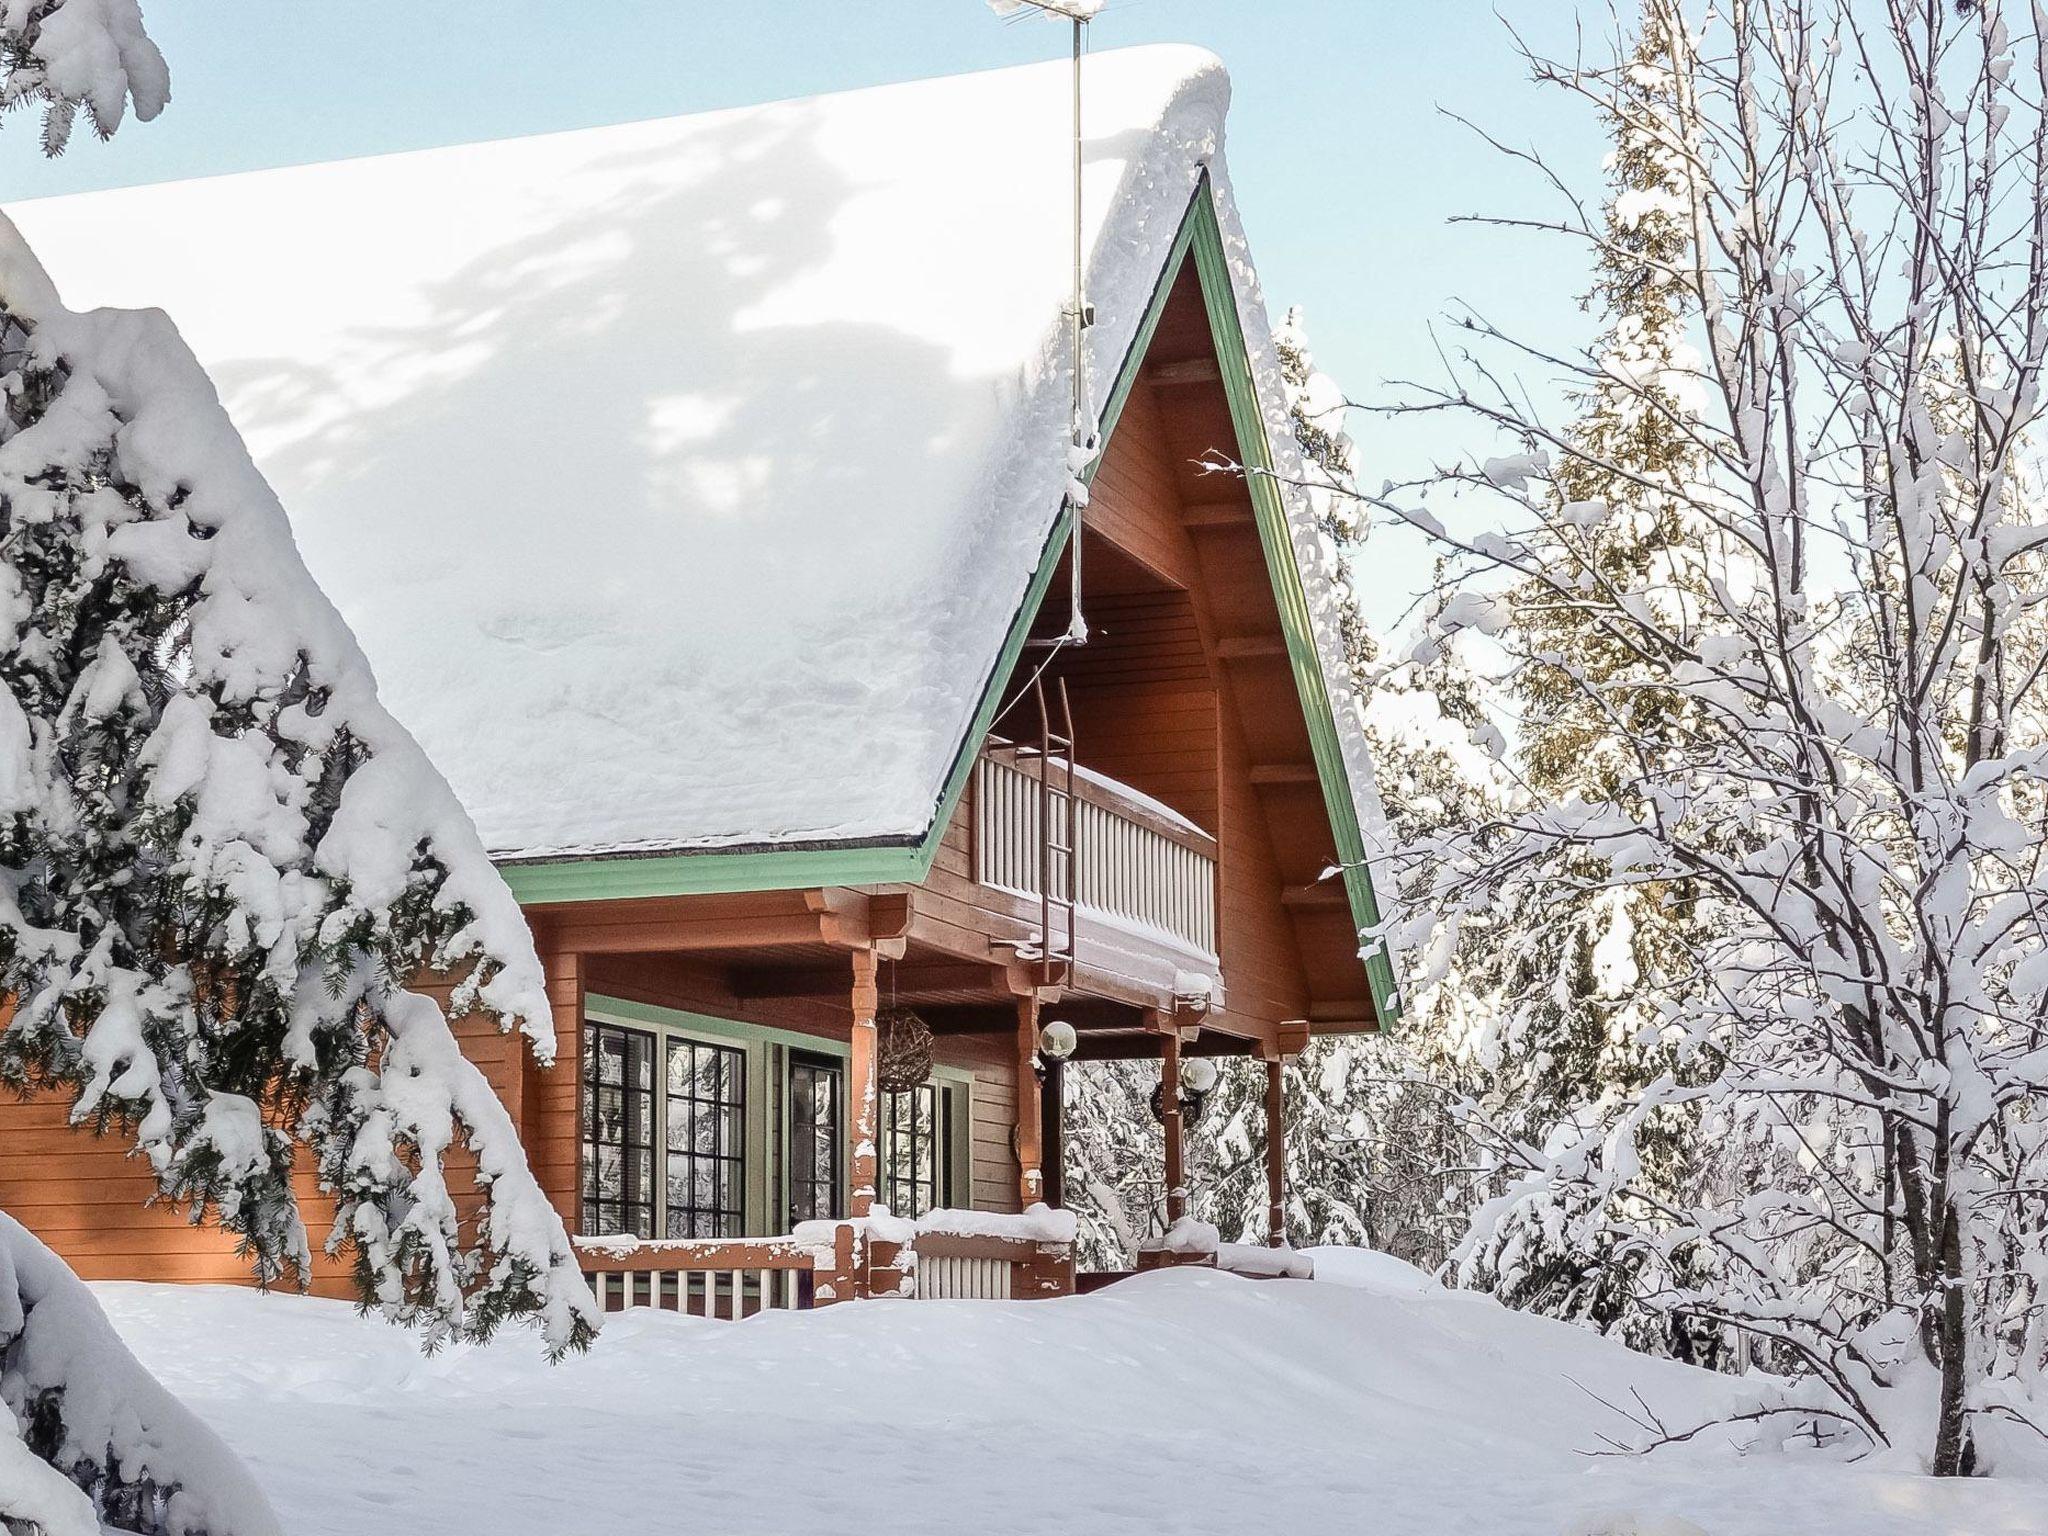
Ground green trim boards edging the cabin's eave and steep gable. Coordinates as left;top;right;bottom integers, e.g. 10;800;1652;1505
500;176;1401;1026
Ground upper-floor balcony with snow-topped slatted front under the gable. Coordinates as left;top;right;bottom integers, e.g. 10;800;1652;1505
975;741;1217;975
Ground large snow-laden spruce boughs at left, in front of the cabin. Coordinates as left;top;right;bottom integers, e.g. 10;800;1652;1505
0;210;594;1350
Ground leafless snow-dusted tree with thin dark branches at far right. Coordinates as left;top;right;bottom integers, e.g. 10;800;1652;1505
1386;0;2048;1475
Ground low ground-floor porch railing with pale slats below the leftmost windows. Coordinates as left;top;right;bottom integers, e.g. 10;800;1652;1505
575;1237;817;1321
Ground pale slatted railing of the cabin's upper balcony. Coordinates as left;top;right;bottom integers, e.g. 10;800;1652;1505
975;745;1217;954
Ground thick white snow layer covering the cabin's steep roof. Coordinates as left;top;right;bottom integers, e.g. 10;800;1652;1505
12;47;1376;884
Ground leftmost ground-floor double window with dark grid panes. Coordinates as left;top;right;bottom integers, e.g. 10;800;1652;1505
582;1022;748;1237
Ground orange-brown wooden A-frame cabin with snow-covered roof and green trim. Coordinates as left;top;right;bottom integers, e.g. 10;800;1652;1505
0;49;1397;1311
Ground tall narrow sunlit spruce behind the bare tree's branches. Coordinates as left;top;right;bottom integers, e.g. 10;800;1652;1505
1460;16;1726;1364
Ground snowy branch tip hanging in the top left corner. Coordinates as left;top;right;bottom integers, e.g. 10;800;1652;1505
0;0;170;156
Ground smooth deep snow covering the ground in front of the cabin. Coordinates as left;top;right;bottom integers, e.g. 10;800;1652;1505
96;1255;2048;1536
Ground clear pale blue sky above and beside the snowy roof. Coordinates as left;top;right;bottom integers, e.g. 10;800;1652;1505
0;0;1606;625
